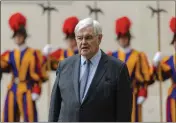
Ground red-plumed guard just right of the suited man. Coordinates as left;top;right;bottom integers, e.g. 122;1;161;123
108;16;153;122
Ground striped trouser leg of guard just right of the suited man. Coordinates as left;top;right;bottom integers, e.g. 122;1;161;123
131;93;142;122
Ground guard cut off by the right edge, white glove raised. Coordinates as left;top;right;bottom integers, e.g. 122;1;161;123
153;17;176;122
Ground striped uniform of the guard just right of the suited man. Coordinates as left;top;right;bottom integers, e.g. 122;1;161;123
108;49;153;122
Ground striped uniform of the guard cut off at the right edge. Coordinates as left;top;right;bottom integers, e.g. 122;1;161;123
155;55;176;122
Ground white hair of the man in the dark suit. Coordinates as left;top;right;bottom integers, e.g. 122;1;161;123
75;18;102;35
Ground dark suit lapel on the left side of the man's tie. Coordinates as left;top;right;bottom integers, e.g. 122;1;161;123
73;55;80;103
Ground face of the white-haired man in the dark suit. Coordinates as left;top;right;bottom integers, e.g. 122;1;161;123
76;27;102;59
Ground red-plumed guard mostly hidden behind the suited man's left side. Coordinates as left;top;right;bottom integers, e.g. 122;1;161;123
43;16;79;70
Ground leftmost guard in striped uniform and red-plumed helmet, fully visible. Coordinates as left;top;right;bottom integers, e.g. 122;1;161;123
0;13;48;122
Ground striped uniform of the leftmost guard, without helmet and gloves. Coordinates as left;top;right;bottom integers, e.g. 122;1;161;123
0;47;48;122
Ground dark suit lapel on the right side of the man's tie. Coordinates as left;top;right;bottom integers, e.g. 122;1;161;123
82;51;108;104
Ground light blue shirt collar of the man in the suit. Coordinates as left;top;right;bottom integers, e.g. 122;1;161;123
81;49;102;66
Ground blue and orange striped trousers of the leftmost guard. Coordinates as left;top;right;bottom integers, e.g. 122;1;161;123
2;90;38;122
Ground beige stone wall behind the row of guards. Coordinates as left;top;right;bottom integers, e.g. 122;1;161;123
1;1;175;122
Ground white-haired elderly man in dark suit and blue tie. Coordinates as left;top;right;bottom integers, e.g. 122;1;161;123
49;18;132;122
